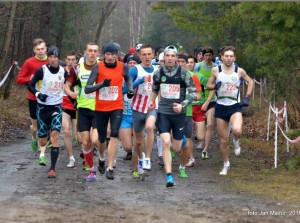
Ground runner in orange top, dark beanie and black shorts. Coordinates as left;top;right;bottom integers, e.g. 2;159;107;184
84;42;133;180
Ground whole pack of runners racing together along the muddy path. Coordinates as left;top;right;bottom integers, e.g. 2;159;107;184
17;39;253;187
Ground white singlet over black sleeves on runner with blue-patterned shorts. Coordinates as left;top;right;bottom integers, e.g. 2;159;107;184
37;65;65;105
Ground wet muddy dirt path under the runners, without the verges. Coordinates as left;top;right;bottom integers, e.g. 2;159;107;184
0;132;300;223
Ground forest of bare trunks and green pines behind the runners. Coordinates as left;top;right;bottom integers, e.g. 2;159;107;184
0;1;300;125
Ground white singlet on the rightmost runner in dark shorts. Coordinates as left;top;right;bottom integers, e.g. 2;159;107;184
216;65;240;105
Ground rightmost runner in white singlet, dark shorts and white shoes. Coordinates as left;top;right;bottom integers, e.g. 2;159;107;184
207;46;253;175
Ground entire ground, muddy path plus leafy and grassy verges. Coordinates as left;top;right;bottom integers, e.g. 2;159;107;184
0;88;300;222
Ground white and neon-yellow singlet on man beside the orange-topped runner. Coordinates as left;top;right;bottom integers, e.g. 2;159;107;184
77;62;96;111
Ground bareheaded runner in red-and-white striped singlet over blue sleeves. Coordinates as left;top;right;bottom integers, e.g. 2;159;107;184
129;44;157;178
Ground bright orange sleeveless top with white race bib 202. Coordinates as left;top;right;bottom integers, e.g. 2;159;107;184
95;61;123;111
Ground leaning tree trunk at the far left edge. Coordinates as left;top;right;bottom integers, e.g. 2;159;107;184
0;2;17;97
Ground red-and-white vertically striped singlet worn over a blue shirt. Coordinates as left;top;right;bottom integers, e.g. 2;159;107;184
132;64;157;113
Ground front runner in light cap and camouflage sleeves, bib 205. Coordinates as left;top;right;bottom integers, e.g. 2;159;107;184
148;46;196;187
